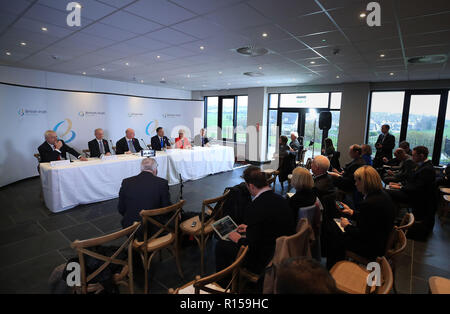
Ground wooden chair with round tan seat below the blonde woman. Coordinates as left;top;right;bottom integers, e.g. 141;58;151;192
330;257;394;294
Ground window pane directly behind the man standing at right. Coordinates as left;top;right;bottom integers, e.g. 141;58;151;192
368;91;405;155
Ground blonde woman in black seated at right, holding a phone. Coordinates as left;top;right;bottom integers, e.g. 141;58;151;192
327;166;394;266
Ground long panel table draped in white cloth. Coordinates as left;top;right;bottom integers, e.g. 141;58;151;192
40;146;234;212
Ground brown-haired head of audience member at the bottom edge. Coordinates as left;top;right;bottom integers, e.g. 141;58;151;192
275;257;341;294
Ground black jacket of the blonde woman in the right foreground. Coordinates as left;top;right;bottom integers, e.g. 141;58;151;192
345;191;395;259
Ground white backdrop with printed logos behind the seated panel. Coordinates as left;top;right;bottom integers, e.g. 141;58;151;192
0;84;203;186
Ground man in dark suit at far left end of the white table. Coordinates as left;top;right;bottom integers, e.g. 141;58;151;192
38;130;87;162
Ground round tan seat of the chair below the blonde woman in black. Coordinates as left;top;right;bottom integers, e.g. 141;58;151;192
330;261;375;294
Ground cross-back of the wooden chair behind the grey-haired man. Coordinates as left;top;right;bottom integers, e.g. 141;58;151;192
139;200;185;252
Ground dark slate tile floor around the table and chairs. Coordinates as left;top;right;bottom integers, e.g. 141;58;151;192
0;168;450;293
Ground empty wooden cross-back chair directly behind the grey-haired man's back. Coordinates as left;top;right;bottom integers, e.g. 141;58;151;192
133;200;185;293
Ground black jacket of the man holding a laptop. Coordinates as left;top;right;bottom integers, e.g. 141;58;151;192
238;190;296;274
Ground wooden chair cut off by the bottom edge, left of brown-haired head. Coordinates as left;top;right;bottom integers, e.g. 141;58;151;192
169;246;248;294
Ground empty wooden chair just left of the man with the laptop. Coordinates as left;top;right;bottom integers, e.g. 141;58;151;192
180;190;229;276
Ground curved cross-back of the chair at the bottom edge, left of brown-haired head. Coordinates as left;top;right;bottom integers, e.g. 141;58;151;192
194;246;248;294
